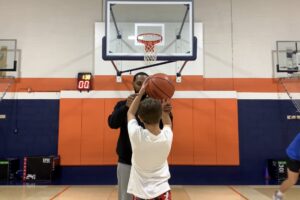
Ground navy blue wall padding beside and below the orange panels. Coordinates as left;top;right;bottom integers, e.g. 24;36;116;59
0;100;300;185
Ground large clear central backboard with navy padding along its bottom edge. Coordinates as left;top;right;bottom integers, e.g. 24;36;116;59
102;0;197;61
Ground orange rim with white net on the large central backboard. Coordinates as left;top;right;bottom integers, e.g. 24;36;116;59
137;33;163;64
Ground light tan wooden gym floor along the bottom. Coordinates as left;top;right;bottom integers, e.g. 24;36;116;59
0;185;300;200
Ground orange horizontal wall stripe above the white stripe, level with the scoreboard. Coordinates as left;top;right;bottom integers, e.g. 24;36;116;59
4;75;290;92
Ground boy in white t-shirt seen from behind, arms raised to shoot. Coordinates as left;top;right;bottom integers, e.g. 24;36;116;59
127;81;173;200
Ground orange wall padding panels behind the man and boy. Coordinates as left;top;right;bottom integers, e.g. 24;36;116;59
58;98;239;166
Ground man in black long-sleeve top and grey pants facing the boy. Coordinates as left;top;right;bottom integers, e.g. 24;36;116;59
108;72;148;200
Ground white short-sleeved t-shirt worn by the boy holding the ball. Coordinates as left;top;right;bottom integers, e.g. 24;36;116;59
127;119;173;199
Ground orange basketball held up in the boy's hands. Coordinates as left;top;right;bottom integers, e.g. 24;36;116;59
146;73;175;99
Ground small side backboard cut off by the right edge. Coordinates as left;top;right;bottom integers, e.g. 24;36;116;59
276;41;300;73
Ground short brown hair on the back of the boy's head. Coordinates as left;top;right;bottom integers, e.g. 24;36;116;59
137;97;162;124
